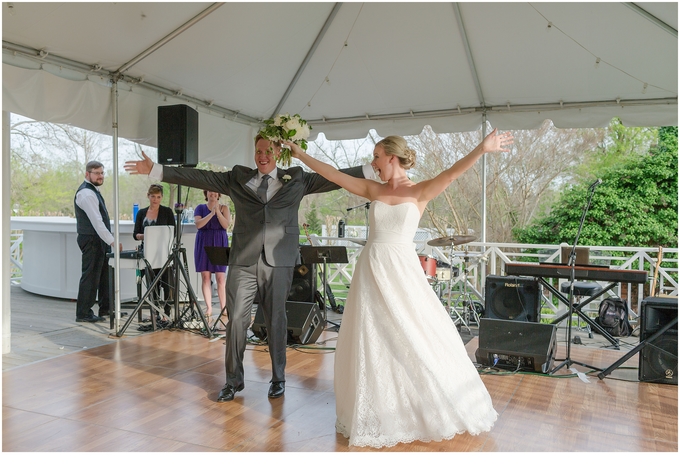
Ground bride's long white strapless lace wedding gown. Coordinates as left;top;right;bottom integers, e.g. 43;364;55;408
335;201;497;447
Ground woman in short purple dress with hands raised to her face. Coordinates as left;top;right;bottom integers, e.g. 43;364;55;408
194;191;231;323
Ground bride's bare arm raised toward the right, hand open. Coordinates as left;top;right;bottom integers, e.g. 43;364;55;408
418;129;514;201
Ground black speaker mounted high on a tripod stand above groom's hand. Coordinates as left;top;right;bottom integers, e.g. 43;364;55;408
158;104;198;166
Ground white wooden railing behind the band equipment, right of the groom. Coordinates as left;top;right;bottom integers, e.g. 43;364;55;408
311;235;678;324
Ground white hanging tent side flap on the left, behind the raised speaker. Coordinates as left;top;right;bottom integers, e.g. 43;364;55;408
2;64;257;167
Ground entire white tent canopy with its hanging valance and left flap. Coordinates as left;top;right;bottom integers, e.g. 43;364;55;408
2;2;678;165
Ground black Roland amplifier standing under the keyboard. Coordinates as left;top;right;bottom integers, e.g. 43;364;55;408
484;276;541;322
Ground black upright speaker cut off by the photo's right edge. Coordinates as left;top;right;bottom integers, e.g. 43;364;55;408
638;297;678;385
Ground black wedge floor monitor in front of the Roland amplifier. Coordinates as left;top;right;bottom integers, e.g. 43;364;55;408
475;318;557;374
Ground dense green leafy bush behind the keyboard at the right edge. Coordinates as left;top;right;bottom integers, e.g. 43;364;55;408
515;127;678;247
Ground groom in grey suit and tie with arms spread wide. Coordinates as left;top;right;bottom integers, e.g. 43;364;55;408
125;135;373;402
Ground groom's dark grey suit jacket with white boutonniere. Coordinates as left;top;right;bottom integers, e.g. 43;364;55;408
163;165;364;267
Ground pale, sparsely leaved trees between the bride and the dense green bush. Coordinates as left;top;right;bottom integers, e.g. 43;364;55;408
408;121;604;242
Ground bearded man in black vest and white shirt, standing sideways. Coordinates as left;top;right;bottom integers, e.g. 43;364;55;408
74;161;115;322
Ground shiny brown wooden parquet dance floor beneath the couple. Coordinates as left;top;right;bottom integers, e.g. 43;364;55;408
2;324;678;454
